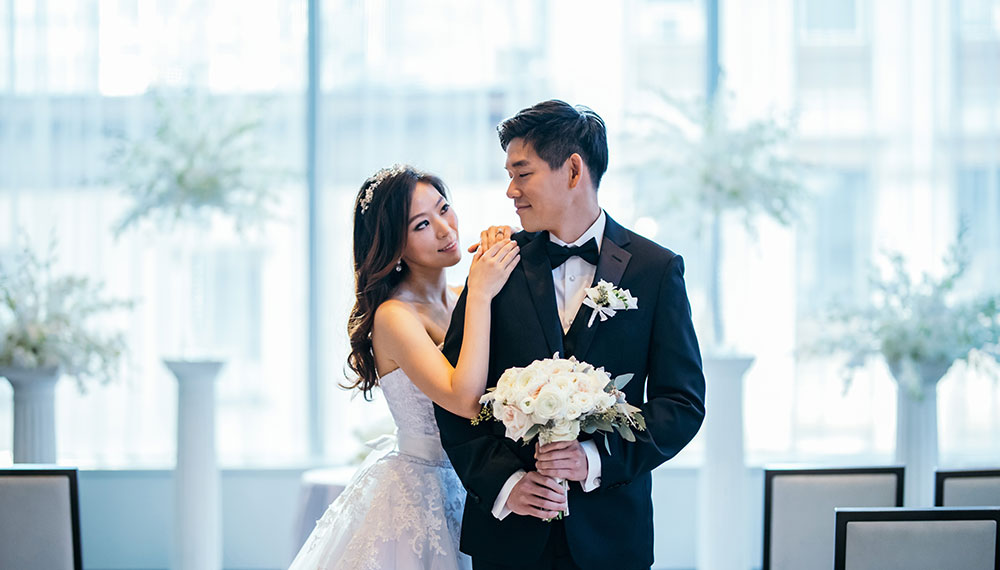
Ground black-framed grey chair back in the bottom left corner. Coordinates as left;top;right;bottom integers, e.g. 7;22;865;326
0;466;83;570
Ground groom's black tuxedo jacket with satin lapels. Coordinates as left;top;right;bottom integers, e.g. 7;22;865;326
435;216;705;569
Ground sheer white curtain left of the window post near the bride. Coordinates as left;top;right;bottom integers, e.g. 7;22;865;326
0;0;308;466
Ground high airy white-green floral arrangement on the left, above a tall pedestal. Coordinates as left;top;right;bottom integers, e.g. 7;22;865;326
111;93;286;236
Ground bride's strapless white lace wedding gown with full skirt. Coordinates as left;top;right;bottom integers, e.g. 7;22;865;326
289;369;472;570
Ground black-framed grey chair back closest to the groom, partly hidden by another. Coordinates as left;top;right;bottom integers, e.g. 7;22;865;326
763;466;903;570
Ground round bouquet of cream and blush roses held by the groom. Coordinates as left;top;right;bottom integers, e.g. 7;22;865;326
472;354;646;518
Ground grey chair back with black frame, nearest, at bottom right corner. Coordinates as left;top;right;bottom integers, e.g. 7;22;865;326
833;507;1000;570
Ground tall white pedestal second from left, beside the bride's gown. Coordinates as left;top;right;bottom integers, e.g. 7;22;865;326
164;360;224;570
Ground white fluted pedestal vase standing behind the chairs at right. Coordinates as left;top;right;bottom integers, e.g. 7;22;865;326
889;363;951;507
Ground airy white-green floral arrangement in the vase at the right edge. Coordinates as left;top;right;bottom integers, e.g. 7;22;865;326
812;230;1000;399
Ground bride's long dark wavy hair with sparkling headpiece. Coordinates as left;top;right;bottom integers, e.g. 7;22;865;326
343;165;448;400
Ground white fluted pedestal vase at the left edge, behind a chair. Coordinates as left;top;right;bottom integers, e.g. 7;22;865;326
0;366;61;463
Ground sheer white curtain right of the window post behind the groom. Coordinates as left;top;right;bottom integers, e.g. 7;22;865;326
724;0;1000;465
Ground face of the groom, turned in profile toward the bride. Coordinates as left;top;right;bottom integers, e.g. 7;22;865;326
505;138;569;232
